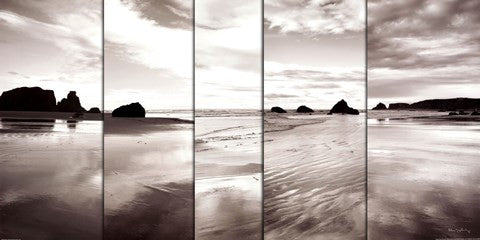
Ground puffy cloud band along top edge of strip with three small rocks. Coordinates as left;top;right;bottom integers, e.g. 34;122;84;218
265;0;365;35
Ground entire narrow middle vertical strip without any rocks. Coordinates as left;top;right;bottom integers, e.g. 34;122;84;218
195;0;262;240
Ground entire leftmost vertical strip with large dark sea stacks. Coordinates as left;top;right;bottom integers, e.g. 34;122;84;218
0;0;103;240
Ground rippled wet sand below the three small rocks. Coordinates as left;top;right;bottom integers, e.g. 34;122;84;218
264;114;365;240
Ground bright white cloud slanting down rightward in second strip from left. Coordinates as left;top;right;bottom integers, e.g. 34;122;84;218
105;0;192;78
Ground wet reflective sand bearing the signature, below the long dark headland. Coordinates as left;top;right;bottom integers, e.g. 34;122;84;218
368;118;480;239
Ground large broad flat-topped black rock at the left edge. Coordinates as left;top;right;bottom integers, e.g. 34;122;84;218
0;87;57;112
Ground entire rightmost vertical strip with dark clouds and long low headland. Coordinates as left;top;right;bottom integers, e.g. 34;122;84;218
367;0;480;239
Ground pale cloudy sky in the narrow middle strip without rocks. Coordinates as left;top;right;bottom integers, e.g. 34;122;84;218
195;0;262;109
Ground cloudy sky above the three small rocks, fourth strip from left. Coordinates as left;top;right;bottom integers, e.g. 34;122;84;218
264;0;365;109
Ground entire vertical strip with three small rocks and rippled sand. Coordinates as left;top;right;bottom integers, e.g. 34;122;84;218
263;0;366;240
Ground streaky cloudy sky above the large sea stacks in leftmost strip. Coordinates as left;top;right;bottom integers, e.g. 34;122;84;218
0;0;102;109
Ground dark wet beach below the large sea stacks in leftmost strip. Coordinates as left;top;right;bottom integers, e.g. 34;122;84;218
0;120;102;239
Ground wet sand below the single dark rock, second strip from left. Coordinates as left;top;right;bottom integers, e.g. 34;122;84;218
104;115;193;240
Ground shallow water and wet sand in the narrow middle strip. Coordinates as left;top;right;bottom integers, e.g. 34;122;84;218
195;113;262;240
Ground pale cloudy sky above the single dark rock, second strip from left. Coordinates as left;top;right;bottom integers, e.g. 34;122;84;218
105;0;193;110
